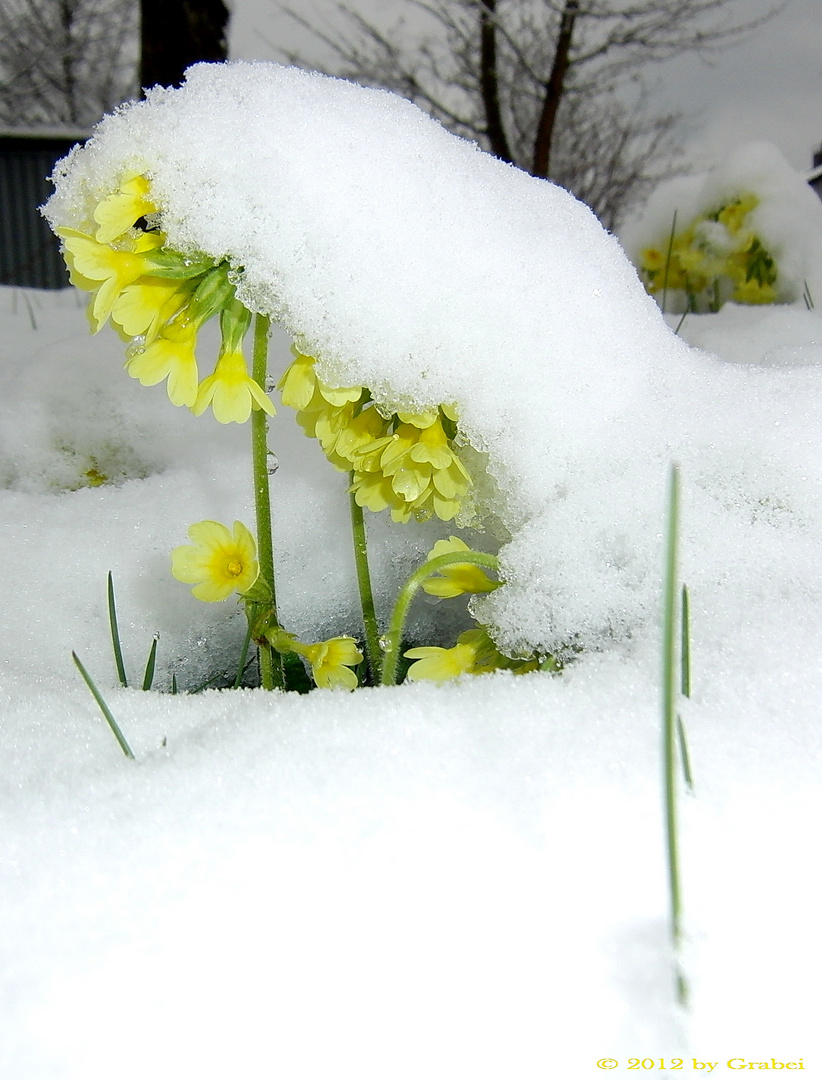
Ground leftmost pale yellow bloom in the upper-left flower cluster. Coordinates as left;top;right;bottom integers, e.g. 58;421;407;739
56;229;163;334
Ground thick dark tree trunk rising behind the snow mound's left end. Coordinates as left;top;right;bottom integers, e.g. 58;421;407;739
139;0;229;91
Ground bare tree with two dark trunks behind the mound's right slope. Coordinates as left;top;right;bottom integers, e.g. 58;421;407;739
274;0;787;227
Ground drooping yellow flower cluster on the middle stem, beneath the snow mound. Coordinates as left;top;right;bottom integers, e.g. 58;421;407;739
280;347;471;522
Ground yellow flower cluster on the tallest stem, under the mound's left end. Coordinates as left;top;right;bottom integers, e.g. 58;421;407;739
56;174;274;423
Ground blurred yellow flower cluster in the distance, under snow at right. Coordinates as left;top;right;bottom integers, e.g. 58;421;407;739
639;193;778;312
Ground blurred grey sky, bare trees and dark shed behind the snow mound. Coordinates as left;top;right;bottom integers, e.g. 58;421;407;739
0;0;822;288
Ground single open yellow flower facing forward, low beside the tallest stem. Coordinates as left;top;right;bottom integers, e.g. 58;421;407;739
172;522;259;603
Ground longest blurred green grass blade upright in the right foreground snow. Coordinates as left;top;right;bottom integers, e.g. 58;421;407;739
662;465;686;1003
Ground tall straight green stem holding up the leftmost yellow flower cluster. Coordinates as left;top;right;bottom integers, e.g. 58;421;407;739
252;314;284;690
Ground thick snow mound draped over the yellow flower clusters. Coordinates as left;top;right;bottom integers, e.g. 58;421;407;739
45;64;812;651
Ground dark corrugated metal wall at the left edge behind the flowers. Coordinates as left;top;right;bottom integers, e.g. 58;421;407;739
0;133;81;288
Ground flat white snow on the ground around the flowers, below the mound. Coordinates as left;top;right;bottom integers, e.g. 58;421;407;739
0;289;822;1080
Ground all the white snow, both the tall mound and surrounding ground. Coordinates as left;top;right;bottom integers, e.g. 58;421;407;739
0;65;822;1080
